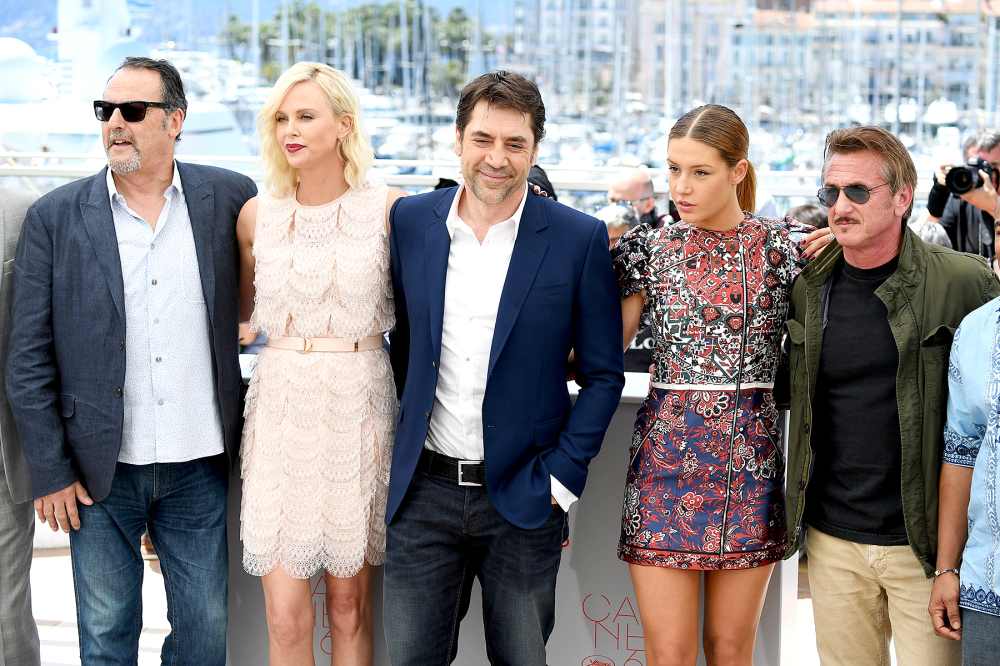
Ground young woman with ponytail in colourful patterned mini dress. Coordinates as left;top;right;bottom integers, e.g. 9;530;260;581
613;104;830;666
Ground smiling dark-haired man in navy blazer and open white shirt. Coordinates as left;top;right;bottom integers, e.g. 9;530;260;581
383;72;624;666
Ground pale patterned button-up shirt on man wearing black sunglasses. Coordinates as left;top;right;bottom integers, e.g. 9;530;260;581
107;163;227;465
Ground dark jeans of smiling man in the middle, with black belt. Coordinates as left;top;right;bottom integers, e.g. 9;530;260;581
383;471;567;666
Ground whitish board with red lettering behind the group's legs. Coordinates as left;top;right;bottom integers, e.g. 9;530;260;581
229;373;797;666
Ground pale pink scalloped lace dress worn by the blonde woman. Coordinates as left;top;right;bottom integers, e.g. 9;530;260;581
240;186;397;578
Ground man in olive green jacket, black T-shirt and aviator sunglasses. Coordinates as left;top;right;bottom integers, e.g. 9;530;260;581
786;127;1000;666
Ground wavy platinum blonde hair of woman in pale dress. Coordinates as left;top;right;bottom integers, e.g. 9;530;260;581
257;62;374;196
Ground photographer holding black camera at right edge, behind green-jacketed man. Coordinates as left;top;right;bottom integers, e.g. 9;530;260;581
927;130;1000;262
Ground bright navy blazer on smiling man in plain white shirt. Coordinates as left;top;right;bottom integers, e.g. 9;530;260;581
386;187;625;528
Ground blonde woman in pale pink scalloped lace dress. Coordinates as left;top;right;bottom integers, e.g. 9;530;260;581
237;62;401;666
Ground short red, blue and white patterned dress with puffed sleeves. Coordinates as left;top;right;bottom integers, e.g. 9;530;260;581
614;215;811;570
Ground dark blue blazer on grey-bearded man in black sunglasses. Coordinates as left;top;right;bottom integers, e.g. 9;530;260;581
7;162;257;501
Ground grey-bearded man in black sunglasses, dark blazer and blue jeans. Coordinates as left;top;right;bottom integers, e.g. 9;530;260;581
6;58;256;666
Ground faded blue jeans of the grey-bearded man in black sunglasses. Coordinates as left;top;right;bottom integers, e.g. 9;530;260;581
70;456;228;666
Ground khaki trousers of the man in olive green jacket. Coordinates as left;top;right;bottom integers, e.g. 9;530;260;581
806;528;961;666
